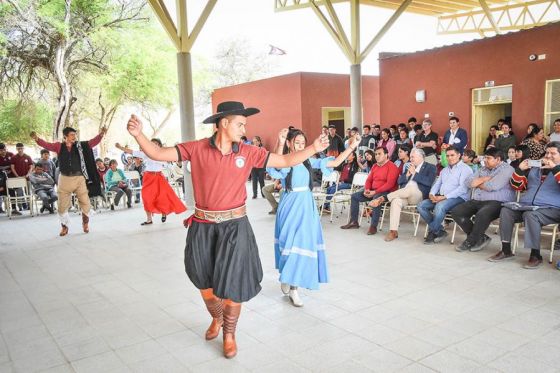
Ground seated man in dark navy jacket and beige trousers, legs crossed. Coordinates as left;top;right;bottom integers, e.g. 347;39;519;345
376;149;436;241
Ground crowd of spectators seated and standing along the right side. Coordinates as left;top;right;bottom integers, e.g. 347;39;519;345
263;116;560;269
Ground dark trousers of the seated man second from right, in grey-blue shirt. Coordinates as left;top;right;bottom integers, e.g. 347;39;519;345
451;200;502;245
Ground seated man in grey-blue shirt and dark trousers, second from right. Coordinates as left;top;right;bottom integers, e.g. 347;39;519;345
451;148;515;251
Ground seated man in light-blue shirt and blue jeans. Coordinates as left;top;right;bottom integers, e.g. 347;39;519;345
417;146;473;245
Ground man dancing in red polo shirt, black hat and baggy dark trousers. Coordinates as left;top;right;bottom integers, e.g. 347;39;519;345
127;101;329;358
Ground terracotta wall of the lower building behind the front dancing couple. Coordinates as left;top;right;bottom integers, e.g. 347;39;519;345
212;72;379;149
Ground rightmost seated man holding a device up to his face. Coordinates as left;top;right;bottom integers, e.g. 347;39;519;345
488;141;560;269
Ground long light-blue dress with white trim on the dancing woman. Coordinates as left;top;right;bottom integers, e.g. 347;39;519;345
267;157;334;290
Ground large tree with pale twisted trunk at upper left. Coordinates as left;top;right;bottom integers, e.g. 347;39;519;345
0;0;147;139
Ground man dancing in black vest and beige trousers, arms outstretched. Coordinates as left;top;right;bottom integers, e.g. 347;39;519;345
31;127;107;236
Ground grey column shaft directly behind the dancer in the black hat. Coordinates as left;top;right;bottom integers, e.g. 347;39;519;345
177;52;196;209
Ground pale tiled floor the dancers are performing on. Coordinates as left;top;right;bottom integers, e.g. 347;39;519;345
0;187;560;373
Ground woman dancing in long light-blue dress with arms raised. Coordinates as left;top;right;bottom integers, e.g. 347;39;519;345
267;129;361;307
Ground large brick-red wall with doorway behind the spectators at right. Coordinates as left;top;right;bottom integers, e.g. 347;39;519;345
379;23;560;140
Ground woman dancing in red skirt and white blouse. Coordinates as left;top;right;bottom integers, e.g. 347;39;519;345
115;139;187;225
